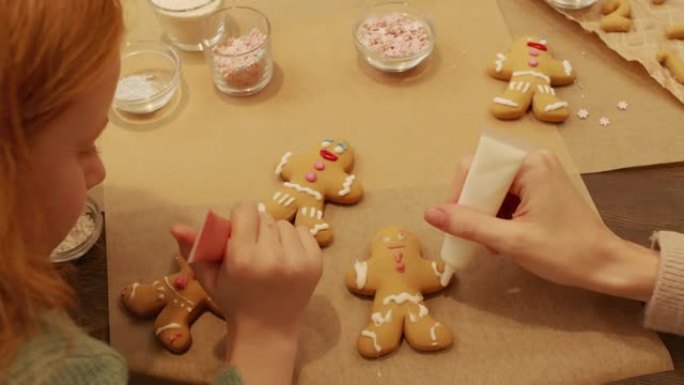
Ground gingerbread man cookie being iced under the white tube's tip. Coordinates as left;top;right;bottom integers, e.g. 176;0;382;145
346;227;453;358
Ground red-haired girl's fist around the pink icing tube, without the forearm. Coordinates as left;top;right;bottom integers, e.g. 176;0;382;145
172;204;322;329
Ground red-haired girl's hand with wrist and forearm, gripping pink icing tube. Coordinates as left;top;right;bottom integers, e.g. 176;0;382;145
172;204;322;385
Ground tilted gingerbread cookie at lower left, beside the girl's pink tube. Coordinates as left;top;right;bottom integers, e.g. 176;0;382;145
121;256;223;354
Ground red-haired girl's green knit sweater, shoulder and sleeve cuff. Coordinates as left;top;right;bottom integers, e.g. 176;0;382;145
6;312;242;385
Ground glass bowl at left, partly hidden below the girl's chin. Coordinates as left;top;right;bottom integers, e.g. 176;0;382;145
50;196;104;262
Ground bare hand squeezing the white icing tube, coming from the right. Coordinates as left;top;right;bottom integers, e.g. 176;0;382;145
425;151;658;301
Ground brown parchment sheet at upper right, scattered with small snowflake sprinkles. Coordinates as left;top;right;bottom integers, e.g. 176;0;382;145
498;0;684;173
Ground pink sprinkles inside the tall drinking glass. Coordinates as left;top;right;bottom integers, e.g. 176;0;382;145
212;28;266;88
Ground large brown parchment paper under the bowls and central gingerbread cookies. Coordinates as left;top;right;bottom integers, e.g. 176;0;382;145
101;0;671;384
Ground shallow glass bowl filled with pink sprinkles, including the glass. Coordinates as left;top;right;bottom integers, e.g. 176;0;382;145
353;2;435;72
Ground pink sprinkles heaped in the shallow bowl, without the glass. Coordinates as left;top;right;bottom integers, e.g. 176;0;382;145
356;13;431;58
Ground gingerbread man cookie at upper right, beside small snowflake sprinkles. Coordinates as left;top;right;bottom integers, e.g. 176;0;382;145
487;37;575;122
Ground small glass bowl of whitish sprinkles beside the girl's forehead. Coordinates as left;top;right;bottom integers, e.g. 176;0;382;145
114;41;181;114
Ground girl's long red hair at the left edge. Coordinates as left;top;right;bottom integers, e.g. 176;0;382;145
0;0;124;373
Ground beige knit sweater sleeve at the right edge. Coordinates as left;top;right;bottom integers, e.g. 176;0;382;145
644;231;684;335
